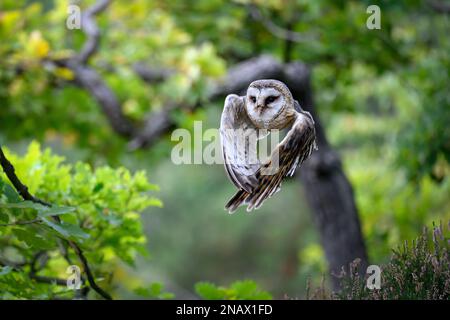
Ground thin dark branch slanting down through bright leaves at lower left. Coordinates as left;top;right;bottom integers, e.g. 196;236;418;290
0;146;112;300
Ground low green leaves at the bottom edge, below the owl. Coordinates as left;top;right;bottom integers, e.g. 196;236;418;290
195;280;272;300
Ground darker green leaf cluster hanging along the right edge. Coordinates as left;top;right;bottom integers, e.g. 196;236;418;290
397;48;450;183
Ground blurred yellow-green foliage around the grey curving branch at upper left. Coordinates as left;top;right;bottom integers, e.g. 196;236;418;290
0;0;225;157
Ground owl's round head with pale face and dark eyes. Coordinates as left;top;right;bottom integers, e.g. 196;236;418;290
245;79;294;129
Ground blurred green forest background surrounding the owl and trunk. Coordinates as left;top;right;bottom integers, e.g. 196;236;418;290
0;0;450;299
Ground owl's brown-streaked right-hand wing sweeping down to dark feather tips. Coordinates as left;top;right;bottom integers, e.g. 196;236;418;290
225;111;317;213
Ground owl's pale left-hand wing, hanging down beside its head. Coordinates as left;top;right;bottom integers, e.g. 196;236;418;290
220;94;268;193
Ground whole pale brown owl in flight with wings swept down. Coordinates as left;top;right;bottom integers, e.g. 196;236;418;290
220;80;317;213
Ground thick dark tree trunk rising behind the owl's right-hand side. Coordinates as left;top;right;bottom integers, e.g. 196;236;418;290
285;62;368;289
